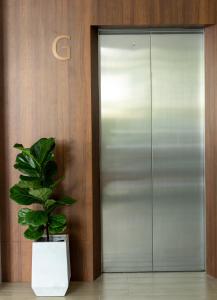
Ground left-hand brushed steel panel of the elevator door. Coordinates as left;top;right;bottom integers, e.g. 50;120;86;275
99;35;152;272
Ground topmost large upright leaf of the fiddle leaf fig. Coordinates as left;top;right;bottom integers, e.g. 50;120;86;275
30;138;55;164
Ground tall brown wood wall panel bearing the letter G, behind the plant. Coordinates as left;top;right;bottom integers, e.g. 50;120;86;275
2;0;93;281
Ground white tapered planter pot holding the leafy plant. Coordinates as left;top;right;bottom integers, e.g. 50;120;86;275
32;235;71;296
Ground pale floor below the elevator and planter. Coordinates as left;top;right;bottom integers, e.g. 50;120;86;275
0;273;217;300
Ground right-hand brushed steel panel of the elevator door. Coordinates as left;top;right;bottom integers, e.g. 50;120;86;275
151;34;205;271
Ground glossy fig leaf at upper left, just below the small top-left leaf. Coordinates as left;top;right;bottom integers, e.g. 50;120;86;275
14;153;40;177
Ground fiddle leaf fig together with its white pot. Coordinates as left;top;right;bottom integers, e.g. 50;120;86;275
10;138;75;296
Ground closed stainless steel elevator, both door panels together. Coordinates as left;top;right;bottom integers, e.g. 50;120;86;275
99;29;205;272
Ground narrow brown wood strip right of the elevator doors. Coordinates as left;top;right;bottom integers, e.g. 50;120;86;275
205;25;217;277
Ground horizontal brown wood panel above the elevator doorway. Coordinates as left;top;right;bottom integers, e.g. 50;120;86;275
95;0;217;26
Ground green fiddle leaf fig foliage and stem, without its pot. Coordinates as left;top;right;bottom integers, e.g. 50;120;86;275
10;138;76;241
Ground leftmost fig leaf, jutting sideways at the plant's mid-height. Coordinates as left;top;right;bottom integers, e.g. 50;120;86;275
10;184;41;205
